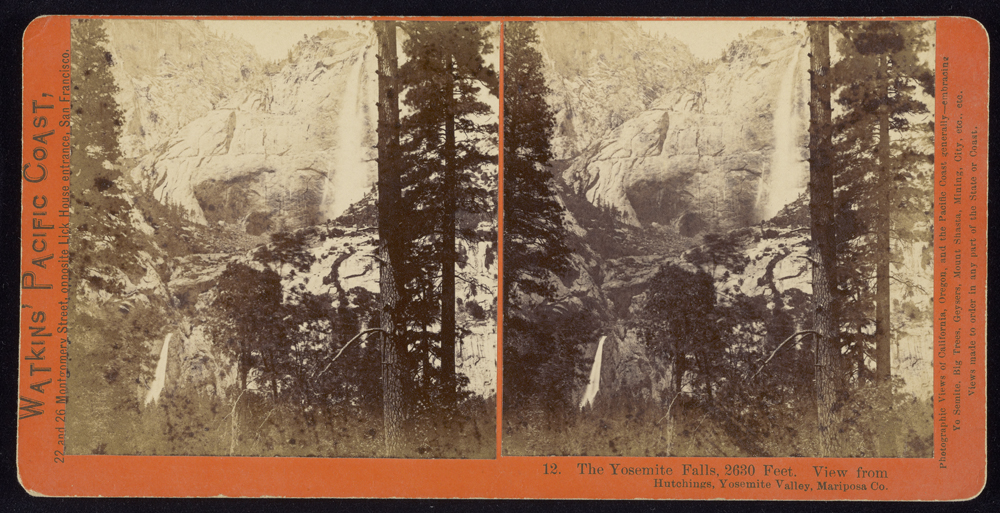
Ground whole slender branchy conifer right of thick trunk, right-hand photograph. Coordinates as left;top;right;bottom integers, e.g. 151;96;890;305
835;21;934;382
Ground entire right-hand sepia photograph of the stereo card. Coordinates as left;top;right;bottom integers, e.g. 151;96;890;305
501;20;936;458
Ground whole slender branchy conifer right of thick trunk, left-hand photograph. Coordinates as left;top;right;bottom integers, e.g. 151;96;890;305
399;22;499;396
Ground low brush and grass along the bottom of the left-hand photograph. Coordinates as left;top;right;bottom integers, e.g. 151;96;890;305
107;386;496;459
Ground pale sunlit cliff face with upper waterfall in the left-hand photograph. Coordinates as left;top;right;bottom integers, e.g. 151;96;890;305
108;21;376;230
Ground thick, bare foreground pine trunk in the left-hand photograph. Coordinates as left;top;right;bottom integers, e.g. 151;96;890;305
375;21;406;456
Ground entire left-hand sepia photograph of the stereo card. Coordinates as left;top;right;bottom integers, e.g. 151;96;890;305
65;19;500;459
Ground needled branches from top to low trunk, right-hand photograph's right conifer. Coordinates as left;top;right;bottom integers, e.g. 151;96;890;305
832;21;934;384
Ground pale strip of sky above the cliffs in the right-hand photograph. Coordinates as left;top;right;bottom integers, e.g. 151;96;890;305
639;20;805;61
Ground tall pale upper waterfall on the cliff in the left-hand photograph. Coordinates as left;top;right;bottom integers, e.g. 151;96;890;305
322;36;374;219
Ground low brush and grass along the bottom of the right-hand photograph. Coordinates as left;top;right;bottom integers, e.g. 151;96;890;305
503;382;934;458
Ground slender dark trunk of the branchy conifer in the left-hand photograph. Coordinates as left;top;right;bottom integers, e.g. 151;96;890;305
441;56;457;396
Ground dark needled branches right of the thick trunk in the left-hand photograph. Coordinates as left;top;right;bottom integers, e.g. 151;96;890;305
396;21;499;403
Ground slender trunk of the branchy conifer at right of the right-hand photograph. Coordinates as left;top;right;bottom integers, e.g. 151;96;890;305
875;51;895;456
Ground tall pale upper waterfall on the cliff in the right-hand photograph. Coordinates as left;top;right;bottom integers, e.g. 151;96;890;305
757;48;805;219
